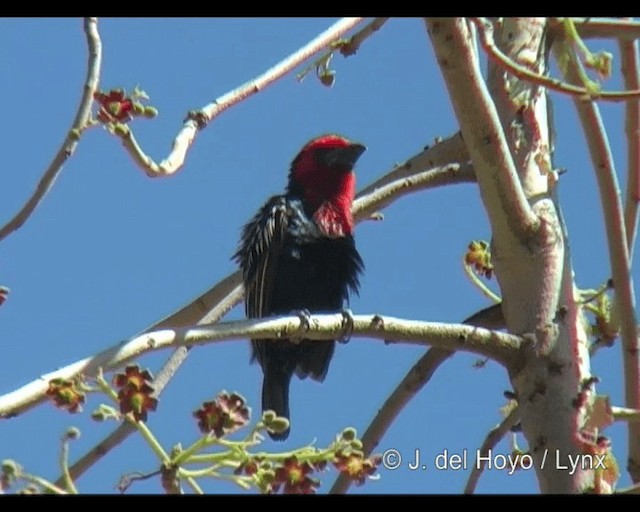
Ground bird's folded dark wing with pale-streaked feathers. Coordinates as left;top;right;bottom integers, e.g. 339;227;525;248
235;196;290;318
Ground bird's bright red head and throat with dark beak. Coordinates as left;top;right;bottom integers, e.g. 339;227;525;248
289;134;366;236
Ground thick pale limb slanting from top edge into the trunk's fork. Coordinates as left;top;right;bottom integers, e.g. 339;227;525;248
426;18;539;242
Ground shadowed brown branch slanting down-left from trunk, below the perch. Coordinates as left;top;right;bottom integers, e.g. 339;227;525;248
329;304;505;494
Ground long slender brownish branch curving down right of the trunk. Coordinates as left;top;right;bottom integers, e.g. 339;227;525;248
554;41;640;482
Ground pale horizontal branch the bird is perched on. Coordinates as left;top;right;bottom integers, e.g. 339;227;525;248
0;314;521;418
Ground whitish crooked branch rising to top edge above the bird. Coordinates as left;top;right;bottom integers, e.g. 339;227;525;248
116;18;363;178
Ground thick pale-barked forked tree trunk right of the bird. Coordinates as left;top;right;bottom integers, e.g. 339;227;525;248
427;18;593;493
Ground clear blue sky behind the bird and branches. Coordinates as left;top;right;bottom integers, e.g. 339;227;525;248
0;18;638;493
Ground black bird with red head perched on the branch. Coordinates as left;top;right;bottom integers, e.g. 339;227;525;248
233;133;367;441
